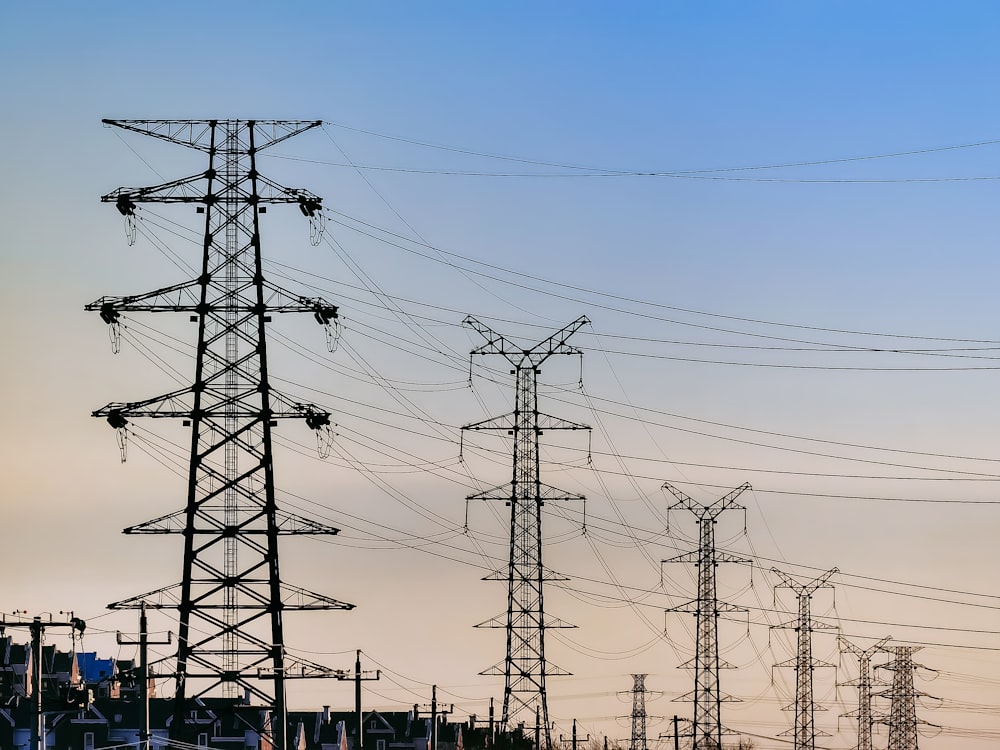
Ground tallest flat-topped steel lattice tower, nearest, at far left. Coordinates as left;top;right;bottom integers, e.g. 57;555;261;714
87;120;352;750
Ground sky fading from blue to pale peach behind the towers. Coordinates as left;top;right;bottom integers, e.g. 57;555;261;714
0;1;1000;750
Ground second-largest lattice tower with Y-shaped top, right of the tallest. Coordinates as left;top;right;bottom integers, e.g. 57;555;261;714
462;317;590;748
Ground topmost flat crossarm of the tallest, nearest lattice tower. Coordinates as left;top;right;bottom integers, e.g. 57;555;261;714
101;118;323;152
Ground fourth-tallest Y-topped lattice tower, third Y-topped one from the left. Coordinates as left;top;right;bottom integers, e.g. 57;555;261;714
771;568;838;750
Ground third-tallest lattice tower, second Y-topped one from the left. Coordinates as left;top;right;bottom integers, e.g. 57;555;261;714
663;483;750;750
